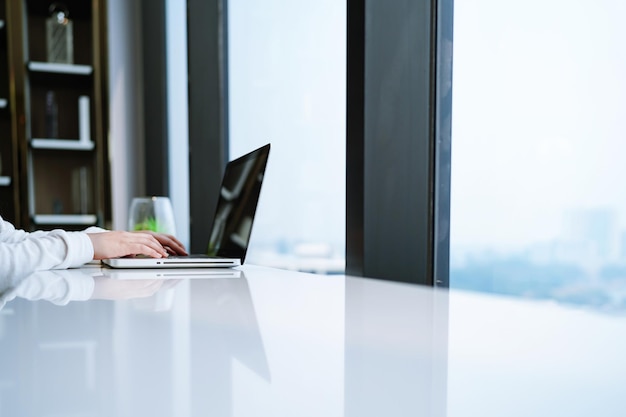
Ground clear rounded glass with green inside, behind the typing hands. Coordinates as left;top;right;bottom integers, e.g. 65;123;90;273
128;197;176;235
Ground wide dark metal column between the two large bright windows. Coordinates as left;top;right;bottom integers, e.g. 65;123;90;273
346;0;452;285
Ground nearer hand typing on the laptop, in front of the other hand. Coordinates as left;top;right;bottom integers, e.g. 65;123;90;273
87;232;167;260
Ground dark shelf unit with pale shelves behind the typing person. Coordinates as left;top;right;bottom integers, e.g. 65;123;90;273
0;0;110;230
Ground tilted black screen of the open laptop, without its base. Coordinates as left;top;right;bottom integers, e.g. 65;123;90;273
207;144;270;264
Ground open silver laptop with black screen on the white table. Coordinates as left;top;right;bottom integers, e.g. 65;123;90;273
102;143;270;268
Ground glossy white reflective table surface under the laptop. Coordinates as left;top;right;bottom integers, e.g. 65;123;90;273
0;266;626;417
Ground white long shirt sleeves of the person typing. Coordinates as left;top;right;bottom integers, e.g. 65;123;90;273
0;217;101;288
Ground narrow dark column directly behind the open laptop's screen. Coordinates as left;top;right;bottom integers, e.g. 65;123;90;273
187;0;228;253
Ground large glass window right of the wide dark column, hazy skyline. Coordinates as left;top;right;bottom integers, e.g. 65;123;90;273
450;0;626;308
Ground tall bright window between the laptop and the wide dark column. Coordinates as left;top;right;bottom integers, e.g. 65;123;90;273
228;0;346;273
